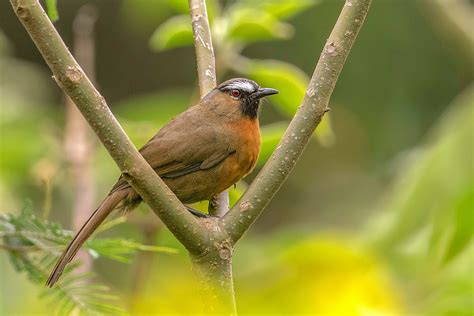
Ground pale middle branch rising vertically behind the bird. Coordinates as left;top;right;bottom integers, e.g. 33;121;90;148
189;0;229;217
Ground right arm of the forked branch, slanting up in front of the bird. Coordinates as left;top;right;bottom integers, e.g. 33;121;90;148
220;0;371;244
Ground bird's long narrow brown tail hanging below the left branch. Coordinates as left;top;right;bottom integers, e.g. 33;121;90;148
46;190;128;287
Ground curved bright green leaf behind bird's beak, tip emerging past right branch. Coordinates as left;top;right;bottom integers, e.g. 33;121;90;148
244;60;335;146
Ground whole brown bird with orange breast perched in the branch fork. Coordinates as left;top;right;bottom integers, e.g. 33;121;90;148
46;78;279;287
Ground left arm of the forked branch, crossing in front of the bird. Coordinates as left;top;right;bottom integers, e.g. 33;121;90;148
10;0;208;253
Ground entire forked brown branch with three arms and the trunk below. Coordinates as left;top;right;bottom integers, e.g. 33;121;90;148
10;0;371;314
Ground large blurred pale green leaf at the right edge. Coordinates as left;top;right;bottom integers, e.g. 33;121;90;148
366;87;474;262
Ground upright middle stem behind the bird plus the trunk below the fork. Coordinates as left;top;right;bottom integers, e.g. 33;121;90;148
189;0;236;314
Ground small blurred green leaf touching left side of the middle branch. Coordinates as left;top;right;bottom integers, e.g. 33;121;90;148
150;15;193;52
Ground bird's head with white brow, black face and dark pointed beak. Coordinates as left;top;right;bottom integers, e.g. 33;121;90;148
206;78;278;118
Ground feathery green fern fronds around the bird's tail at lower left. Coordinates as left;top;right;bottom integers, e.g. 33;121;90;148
0;208;176;315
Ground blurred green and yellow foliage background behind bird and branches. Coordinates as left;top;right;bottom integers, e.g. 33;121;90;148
0;0;474;315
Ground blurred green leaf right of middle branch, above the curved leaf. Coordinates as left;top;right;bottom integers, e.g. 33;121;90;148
224;5;294;43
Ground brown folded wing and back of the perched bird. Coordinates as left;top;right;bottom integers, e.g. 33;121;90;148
112;107;235;192
